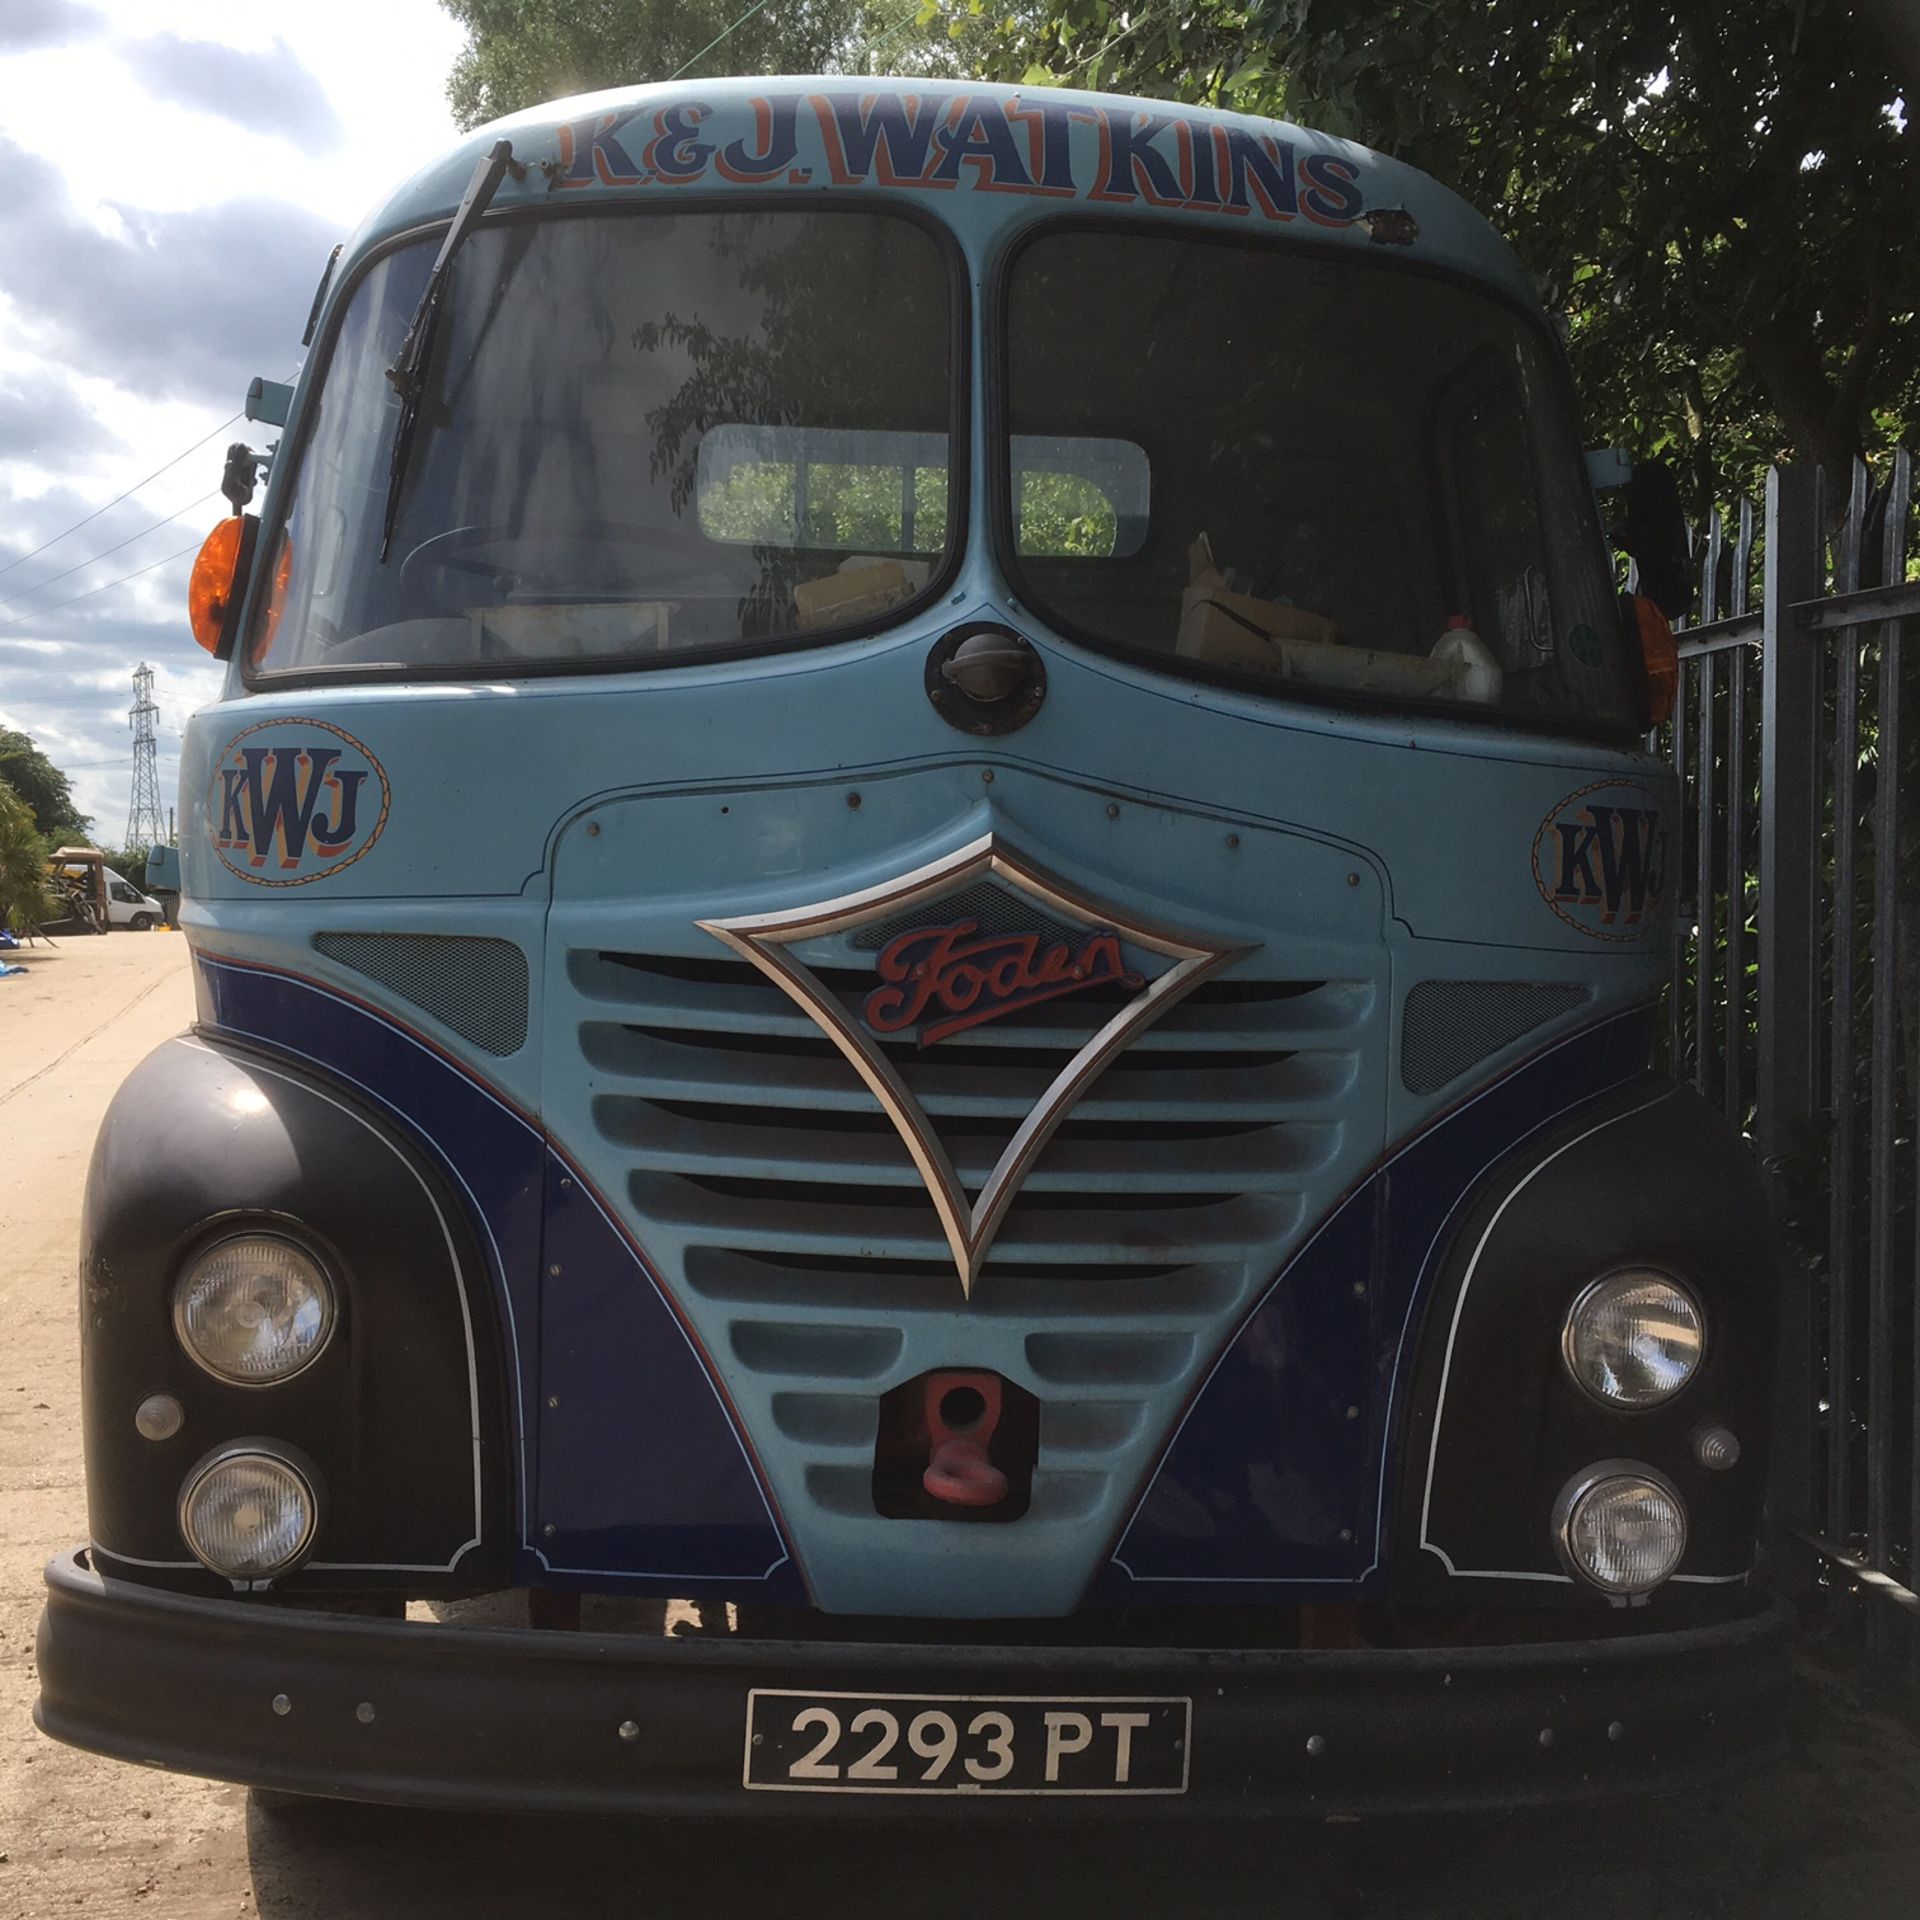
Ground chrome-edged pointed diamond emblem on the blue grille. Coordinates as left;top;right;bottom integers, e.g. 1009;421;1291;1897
699;833;1248;1296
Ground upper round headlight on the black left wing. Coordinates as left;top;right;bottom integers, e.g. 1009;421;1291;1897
173;1233;336;1386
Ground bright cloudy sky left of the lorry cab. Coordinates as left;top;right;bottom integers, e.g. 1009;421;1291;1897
0;0;461;847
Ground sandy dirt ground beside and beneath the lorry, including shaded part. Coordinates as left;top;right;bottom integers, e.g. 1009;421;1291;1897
0;933;1920;1920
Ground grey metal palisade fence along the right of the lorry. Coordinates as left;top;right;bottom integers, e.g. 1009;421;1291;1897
1667;451;1920;1649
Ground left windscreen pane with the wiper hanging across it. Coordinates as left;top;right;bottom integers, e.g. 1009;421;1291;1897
250;211;954;676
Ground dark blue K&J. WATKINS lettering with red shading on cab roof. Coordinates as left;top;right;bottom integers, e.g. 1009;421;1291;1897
555;92;1361;227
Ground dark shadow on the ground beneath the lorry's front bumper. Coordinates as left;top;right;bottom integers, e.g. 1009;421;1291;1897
248;1657;1920;1920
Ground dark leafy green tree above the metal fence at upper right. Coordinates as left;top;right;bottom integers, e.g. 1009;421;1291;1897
993;0;1920;526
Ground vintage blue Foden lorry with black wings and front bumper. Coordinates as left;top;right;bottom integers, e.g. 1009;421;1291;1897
38;81;1784;1816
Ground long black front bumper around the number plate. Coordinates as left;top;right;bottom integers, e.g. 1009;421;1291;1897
35;1553;1791;1822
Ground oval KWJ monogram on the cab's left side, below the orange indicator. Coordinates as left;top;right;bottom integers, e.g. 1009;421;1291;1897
207;720;390;887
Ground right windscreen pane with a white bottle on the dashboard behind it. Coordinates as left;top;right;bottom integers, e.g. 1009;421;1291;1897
1002;228;1634;732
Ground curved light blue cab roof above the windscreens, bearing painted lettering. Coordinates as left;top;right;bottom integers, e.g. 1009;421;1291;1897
336;75;1538;309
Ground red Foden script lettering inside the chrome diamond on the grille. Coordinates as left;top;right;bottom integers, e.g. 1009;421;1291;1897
862;920;1146;1046
